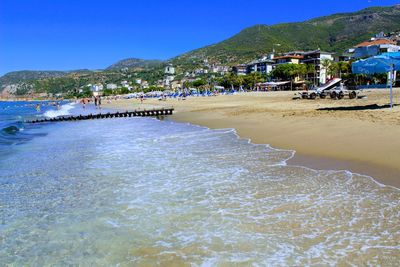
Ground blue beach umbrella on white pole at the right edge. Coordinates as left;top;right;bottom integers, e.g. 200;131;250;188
351;52;400;108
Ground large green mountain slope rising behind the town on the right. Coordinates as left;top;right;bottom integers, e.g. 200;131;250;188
172;5;400;65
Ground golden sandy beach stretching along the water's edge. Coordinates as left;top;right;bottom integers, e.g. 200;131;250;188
105;88;400;188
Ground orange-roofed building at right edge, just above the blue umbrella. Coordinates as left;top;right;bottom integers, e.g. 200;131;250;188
354;39;400;58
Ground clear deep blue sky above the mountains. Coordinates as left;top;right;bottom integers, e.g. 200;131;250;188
0;0;400;75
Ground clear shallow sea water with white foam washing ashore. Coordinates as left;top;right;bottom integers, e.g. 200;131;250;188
0;101;400;266
